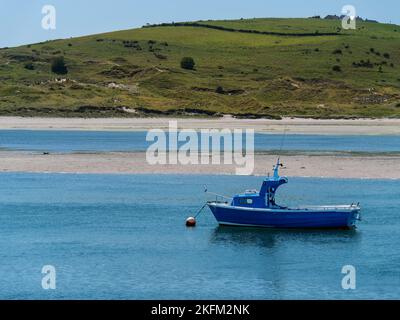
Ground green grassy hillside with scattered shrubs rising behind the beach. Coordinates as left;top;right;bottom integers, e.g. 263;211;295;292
0;19;400;118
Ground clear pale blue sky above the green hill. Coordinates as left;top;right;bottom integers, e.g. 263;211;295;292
0;0;400;47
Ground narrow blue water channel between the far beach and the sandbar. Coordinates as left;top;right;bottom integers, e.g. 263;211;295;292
0;130;400;152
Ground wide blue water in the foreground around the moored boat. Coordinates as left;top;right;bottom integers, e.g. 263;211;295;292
0;173;400;299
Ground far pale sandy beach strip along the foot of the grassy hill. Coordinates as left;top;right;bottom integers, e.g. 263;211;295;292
0;116;400;135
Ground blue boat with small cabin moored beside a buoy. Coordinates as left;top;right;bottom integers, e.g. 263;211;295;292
207;159;360;229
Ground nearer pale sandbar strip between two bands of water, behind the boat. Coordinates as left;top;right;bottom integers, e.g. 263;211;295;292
0;151;400;179
